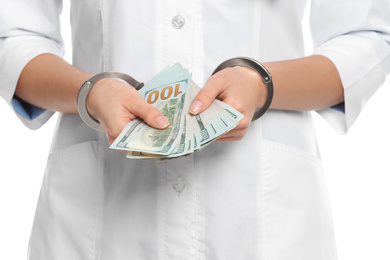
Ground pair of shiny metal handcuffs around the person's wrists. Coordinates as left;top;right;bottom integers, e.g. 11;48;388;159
77;57;274;132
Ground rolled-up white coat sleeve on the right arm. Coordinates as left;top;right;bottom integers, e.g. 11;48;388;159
310;0;390;134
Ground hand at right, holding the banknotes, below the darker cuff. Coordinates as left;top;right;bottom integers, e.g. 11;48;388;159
190;67;265;142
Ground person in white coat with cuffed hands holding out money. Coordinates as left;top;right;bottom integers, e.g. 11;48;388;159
0;0;390;260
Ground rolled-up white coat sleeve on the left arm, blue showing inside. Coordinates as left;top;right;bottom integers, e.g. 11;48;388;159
0;0;63;129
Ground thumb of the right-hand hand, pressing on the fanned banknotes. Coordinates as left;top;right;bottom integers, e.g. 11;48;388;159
190;80;219;115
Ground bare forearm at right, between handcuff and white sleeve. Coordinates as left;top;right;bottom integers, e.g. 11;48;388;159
264;55;344;111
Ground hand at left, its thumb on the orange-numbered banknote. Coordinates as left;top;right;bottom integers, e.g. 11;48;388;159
86;78;169;144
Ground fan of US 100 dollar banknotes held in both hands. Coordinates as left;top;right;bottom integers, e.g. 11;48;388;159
110;63;244;159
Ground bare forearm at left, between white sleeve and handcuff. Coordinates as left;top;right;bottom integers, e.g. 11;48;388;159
15;54;92;113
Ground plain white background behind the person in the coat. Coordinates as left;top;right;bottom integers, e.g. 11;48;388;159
0;1;390;260
